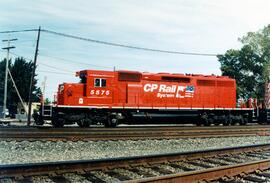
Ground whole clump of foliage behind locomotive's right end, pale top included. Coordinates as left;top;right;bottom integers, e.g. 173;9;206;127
218;25;270;99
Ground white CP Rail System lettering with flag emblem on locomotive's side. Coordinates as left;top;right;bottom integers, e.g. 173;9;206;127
143;84;195;98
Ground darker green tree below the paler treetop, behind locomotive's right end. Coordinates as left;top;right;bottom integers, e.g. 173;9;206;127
218;45;266;99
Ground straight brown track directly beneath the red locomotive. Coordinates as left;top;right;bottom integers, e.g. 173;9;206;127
0;125;270;141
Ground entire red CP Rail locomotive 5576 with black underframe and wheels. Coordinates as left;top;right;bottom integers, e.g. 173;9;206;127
35;70;268;127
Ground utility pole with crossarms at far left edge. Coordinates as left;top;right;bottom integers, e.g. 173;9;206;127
2;39;18;119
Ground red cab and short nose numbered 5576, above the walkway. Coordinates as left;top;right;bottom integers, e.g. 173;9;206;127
57;71;113;106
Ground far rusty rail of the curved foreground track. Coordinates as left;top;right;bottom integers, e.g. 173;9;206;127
0;144;270;178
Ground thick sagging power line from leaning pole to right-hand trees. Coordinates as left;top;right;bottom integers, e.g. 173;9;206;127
41;29;217;57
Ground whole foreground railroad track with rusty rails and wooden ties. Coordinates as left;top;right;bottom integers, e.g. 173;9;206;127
0;144;270;183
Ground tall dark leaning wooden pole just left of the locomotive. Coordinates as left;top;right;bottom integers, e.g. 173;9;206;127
27;26;41;126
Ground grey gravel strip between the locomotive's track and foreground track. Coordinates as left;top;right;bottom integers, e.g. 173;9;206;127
0;136;270;164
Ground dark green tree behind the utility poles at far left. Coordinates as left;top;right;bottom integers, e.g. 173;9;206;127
0;57;41;114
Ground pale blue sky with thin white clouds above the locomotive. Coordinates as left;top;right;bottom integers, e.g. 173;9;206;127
0;0;270;99
